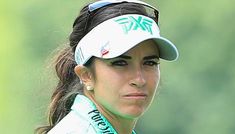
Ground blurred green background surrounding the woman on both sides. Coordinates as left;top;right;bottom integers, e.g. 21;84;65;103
0;0;235;134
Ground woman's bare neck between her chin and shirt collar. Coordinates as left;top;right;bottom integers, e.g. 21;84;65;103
84;92;137;134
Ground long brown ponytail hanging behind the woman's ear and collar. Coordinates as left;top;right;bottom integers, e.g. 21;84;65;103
36;46;83;134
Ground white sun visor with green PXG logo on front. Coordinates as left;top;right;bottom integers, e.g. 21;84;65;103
75;14;178;65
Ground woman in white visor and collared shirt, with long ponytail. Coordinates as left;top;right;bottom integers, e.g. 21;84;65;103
37;0;178;134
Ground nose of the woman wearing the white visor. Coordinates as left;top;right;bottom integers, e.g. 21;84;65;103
130;68;146;88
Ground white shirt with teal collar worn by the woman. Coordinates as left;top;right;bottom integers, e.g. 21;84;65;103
48;95;136;134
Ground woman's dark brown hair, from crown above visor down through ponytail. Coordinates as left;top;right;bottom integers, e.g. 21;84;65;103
36;3;154;134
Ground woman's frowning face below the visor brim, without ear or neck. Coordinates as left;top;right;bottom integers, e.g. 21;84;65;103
93;40;160;118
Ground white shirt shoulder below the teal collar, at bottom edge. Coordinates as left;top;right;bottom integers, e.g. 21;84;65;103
48;111;96;134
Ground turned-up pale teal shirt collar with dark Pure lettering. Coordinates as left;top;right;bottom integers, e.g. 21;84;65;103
71;95;136;134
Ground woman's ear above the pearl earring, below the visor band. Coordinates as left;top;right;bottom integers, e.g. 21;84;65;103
74;65;93;85
